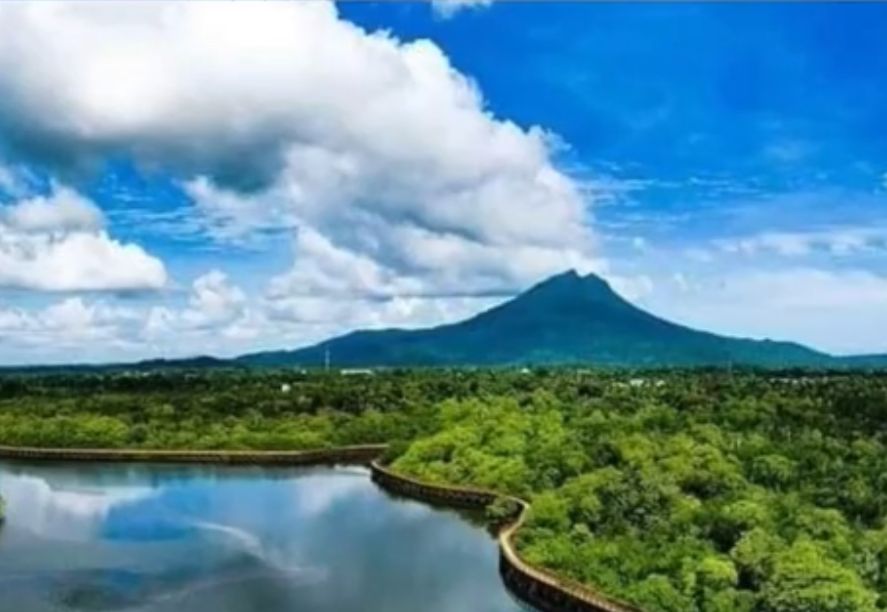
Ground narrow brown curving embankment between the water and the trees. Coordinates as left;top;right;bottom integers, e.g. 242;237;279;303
0;444;641;612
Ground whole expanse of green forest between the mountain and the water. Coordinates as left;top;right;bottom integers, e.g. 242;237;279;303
0;369;887;612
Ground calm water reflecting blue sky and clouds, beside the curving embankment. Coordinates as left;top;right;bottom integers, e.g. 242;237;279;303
0;463;521;612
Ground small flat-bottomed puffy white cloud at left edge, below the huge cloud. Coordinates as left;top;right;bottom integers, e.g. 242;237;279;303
0;187;166;291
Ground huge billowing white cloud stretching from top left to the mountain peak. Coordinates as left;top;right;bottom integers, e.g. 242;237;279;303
0;2;602;304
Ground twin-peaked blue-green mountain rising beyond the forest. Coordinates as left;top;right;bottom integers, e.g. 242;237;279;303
238;271;840;367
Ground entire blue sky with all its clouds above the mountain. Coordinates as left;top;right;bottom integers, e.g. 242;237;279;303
0;0;887;364
